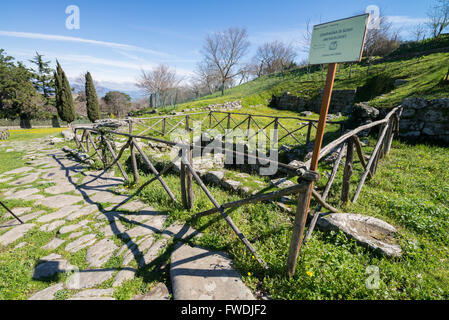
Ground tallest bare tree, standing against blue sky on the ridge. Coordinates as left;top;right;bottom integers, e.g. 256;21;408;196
202;27;250;95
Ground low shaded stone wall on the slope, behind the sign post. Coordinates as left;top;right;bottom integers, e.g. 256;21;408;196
270;90;356;113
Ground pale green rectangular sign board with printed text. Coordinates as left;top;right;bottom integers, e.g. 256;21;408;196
309;13;369;64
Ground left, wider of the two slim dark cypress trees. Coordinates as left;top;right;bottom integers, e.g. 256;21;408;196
55;61;76;123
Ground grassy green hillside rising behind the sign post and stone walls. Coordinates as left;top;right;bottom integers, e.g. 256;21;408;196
169;40;449;110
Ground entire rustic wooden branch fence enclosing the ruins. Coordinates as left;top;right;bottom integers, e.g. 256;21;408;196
73;107;402;274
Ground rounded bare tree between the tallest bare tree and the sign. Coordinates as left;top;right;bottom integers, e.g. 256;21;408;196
253;40;296;75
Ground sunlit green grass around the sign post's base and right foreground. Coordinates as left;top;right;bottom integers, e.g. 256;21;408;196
99;135;449;299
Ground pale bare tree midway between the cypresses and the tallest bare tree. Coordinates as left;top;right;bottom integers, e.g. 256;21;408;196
137;64;182;106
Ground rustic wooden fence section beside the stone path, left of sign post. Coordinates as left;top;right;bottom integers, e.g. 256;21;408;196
73;123;319;268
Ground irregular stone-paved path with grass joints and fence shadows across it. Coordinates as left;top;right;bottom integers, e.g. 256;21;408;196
0;134;252;300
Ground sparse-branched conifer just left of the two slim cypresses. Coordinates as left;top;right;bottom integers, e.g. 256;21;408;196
29;52;55;103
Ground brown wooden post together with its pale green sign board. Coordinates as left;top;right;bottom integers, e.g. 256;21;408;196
287;14;369;277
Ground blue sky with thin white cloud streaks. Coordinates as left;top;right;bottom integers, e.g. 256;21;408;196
0;0;432;95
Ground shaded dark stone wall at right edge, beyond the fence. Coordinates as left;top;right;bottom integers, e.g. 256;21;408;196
400;98;449;143
